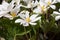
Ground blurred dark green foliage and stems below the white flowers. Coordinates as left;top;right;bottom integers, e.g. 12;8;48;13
0;0;60;40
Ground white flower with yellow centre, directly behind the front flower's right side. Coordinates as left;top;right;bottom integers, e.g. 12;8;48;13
33;1;48;14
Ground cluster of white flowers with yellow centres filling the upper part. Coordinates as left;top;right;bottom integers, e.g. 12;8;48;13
0;0;60;26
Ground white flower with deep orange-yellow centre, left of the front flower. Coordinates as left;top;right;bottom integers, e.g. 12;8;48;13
4;5;20;20
